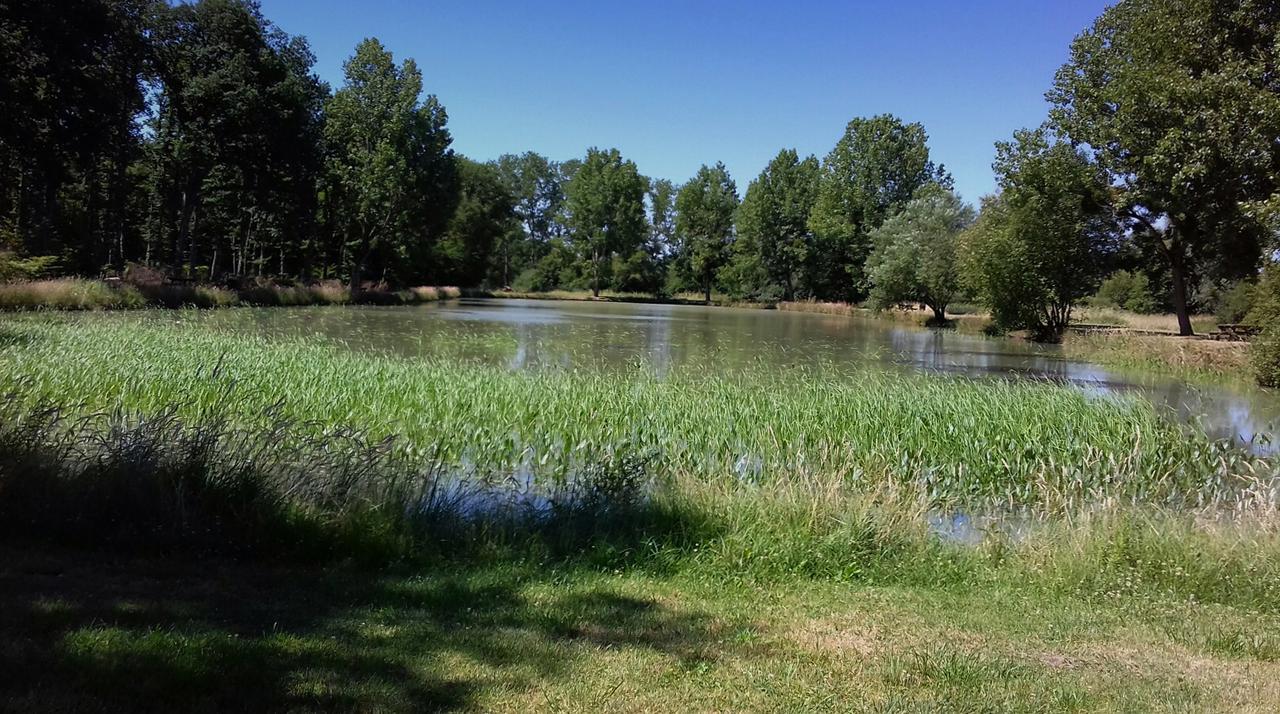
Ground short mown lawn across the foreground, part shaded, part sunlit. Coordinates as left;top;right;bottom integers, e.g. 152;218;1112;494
0;550;1280;711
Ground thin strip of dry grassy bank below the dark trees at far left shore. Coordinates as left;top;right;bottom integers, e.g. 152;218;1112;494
0;278;462;311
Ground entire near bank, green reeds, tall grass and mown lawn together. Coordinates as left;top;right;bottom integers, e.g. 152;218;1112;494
0;315;1280;711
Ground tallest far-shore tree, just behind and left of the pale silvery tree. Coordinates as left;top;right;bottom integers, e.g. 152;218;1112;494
809;114;951;299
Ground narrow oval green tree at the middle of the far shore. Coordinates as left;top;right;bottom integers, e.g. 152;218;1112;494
676;163;739;302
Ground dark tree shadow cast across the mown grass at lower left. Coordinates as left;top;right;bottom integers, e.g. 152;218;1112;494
0;550;718;711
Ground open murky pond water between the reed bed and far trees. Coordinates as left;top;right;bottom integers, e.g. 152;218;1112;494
151;299;1280;452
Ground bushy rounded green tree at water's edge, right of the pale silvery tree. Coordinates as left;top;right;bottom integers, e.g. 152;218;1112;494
961;129;1121;342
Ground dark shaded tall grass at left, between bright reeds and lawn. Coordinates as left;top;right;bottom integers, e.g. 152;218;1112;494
0;395;712;564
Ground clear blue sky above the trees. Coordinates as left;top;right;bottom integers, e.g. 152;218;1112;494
262;0;1106;201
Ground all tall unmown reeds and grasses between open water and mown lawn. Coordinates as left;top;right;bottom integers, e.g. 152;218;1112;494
0;316;1280;609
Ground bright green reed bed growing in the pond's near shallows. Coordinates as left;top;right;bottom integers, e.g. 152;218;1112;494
0;320;1274;511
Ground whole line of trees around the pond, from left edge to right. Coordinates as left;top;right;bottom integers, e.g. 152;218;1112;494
0;0;1280;339
